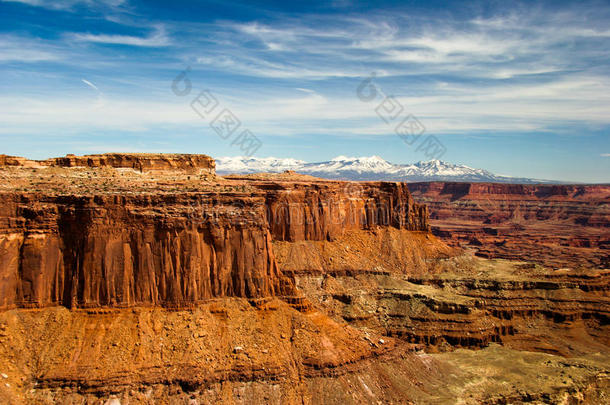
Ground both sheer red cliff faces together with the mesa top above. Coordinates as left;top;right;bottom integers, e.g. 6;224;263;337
0;159;428;308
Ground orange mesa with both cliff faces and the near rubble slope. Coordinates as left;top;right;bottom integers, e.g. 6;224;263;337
0;157;446;403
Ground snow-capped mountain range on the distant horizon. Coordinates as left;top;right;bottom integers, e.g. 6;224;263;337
216;156;549;183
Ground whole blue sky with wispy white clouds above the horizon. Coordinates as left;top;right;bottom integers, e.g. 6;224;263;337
0;0;610;182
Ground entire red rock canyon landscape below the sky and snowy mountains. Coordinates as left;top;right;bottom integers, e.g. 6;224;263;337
0;154;610;404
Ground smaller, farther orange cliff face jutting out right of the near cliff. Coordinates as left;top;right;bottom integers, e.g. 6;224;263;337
256;182;429;241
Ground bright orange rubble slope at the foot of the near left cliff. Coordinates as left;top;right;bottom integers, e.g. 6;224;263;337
0;298;404;404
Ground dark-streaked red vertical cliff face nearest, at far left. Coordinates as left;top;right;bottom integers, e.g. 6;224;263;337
0;195;290;308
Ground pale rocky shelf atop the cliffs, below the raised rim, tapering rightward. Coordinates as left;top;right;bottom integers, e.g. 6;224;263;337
0;166;406;196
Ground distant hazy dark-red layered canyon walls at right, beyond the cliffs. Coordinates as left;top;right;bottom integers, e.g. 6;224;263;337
409;182;610;267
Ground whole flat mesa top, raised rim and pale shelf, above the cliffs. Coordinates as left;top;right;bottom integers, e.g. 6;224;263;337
0;153;408;196
